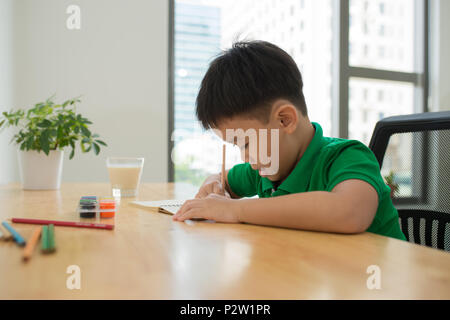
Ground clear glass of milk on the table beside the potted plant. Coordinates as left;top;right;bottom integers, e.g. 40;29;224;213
106;157;144;197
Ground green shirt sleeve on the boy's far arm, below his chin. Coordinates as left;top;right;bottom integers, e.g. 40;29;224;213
227;163;261;197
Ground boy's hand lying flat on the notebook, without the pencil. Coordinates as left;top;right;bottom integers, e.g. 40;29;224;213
173;193;240;223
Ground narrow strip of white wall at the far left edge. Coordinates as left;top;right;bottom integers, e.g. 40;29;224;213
0;0;17;184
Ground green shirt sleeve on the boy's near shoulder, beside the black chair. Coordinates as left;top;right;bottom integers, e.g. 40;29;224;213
327;140;387;200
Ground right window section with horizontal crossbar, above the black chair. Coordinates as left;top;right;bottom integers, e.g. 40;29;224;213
348;0;427;144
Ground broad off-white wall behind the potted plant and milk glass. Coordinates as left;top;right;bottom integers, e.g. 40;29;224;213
0;0;168;183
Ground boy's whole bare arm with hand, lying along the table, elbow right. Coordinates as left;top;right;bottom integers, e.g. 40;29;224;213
174;179;378;233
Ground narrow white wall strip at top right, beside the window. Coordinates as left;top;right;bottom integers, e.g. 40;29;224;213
430;0;450;111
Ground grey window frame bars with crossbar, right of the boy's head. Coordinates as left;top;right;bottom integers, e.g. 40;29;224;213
331;0;430;139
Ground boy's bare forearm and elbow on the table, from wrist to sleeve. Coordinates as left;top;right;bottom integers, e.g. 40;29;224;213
238;179;378;233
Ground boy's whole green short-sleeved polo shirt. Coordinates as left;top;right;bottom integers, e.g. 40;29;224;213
227;122;406;240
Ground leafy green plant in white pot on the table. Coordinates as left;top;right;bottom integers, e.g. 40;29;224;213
0;96;106;190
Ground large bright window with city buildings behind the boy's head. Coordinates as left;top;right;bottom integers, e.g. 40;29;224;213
169;0;427;185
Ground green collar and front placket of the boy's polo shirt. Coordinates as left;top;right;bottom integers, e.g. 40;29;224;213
261;122;325;195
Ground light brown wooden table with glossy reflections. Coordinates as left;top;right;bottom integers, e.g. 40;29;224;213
0;184;450;299
